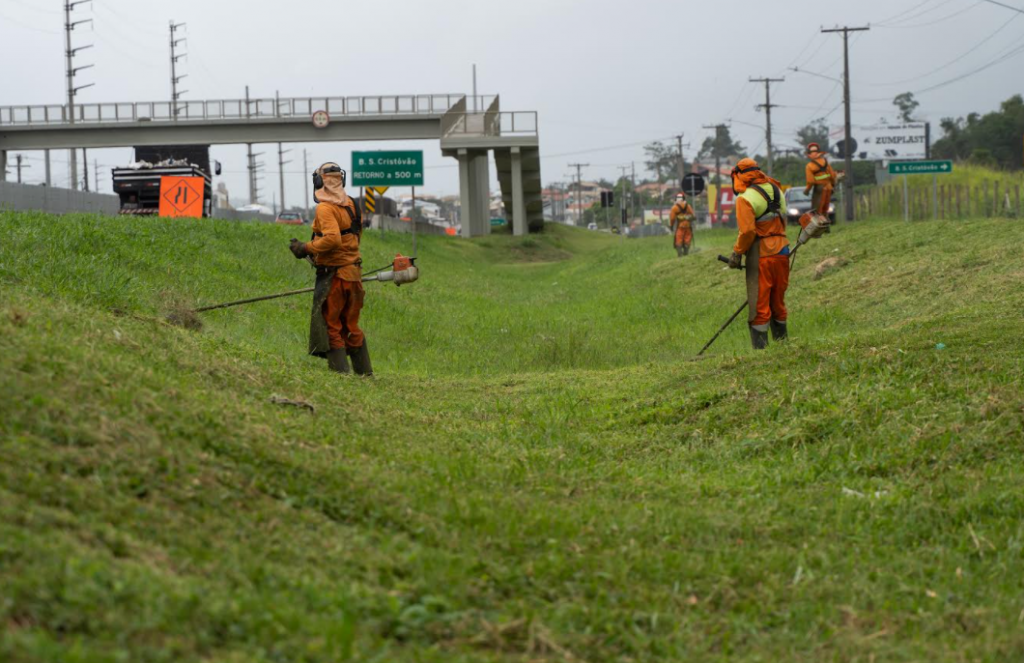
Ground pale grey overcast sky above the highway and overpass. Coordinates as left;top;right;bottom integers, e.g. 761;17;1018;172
0;0;1024;203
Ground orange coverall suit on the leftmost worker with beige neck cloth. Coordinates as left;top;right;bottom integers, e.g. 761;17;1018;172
306;199;365;349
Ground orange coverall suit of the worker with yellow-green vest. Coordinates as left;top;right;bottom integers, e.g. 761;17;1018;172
733;181;790;331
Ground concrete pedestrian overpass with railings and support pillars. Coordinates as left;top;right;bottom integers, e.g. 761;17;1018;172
0;94;544;237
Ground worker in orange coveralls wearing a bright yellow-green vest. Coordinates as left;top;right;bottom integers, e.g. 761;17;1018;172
729;159;790;349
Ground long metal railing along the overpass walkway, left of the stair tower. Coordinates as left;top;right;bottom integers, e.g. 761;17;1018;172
0;94;495;126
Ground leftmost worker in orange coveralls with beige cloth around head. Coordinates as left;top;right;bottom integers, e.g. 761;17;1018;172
290;163;373;376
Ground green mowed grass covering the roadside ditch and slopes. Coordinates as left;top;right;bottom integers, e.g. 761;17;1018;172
0;214;1024;662
